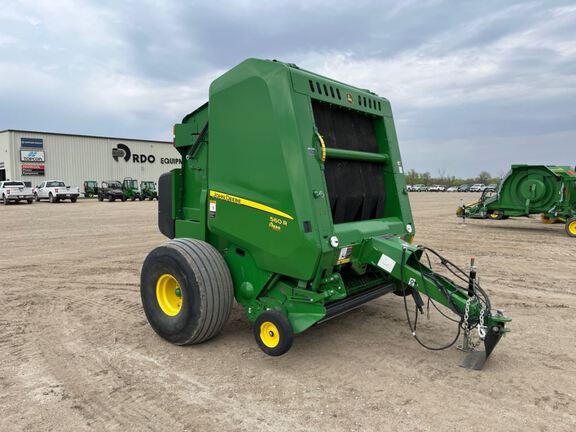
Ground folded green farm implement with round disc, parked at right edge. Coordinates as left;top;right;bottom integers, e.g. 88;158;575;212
456;165;576;237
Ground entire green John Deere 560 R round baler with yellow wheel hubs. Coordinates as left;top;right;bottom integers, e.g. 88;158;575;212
141;59;509;367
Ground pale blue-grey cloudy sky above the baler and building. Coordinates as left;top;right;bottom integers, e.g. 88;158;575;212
0;0;576;176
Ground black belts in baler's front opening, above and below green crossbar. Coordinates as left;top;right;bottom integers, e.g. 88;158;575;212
312;101;385;224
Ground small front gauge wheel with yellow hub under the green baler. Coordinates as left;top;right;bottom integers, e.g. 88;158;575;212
253;309;294;357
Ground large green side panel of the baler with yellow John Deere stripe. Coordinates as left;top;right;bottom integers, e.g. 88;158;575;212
208;60;320;280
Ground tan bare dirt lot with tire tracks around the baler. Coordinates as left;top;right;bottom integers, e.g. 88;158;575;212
0;193;576;432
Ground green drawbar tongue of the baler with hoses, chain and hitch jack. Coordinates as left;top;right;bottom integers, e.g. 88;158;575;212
361;236;511;370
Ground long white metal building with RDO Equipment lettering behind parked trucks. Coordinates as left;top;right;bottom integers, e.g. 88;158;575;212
0;129;182;188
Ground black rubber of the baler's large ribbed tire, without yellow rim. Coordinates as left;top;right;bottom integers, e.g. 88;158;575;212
140;239;234;345
